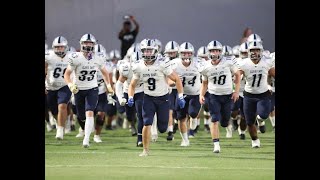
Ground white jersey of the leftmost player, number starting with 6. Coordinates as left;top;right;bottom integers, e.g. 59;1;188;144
45;50;70;91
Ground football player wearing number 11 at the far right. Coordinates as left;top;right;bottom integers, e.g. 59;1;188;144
239;41;275;148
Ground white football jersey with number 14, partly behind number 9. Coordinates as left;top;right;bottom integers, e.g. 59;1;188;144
172;58;200;95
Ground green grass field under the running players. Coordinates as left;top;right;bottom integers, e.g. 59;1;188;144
45;120;275;180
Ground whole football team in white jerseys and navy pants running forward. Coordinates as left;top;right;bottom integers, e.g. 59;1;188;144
45;34;275;156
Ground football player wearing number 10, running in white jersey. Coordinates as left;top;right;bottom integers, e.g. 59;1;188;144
199;40;240;153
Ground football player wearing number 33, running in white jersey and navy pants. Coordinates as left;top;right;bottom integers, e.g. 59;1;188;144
64;34;113;148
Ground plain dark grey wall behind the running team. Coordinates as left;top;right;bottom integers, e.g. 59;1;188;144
45;0;275;52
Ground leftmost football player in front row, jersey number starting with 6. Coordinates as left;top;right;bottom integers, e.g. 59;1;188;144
45;36;71;140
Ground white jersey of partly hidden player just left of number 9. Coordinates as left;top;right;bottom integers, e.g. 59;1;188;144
119;61;143;94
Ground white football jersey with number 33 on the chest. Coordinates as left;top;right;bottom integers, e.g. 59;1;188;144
68;52;105;90
